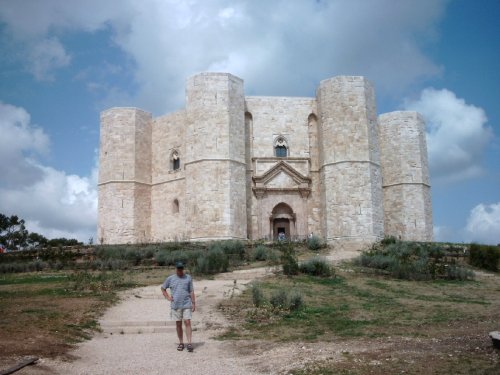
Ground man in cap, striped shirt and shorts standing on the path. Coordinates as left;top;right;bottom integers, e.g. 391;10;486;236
161;262;196;352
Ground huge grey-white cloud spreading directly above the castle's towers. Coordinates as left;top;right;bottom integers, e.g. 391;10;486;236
0;0;447;114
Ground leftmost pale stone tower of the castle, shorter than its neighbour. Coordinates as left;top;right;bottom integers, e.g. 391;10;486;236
97;108;152;243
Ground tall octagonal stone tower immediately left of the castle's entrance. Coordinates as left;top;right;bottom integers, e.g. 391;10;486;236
185;73;247;239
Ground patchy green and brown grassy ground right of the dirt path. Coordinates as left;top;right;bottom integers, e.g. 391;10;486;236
221;268;500;374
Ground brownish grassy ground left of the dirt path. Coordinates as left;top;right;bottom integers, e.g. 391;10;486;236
0;269;169;361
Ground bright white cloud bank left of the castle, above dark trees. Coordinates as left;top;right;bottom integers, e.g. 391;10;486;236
0;103;97;242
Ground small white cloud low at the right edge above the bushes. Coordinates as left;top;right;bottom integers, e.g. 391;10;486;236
465;202;500;245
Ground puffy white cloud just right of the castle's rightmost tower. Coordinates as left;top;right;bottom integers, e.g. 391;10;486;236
404;88;493;182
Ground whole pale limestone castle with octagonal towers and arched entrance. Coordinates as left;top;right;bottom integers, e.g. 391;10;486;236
97;73;433;246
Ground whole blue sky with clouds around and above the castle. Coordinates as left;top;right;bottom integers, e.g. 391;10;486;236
0;0;500;244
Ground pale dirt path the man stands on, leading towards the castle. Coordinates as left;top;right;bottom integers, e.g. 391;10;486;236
19;253;369;375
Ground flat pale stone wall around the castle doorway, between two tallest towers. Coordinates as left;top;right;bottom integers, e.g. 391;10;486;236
245;96;320;239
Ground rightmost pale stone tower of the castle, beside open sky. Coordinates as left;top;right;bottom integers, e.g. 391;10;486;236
378;111;433;241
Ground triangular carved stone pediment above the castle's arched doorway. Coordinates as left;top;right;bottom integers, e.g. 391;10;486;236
253;160;311;198
